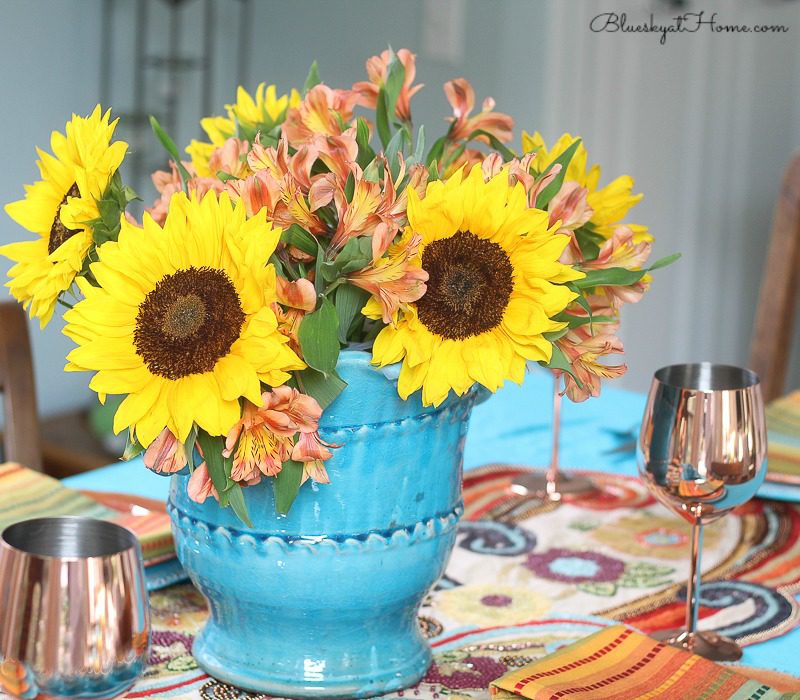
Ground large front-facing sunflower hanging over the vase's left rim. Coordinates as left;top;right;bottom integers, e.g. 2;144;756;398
64;192;305;447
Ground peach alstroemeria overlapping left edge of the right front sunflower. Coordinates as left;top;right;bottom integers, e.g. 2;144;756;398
348;230;428;323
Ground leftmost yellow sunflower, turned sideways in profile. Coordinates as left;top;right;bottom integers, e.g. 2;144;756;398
0;105;128;327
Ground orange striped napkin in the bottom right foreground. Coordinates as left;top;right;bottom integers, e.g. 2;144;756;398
490;625;800;700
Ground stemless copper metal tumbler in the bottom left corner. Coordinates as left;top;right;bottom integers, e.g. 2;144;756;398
0;517;150;700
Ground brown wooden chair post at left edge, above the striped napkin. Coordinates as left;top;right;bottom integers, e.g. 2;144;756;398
0;301;42;471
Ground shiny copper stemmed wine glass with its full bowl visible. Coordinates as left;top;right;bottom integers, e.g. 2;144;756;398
638;362;767;661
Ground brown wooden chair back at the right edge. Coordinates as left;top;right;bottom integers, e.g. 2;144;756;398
750;153;800;401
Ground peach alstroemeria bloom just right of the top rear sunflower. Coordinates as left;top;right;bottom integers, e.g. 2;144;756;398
282;84;358;147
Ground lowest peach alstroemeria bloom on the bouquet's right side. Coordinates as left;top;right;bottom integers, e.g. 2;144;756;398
556;323;628;403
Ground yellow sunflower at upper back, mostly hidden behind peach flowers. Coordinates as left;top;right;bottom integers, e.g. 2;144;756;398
186;83;300;177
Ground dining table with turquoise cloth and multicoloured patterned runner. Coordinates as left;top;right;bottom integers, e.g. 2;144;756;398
36;369;800;698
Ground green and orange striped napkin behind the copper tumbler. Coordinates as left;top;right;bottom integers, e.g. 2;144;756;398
0;463;175;568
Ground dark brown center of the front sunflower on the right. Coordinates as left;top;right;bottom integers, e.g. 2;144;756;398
417;231;514;340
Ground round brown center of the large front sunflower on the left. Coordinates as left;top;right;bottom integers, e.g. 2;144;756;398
133;267;245;379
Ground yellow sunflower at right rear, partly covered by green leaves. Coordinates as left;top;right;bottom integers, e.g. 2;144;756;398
522;131;653;243
